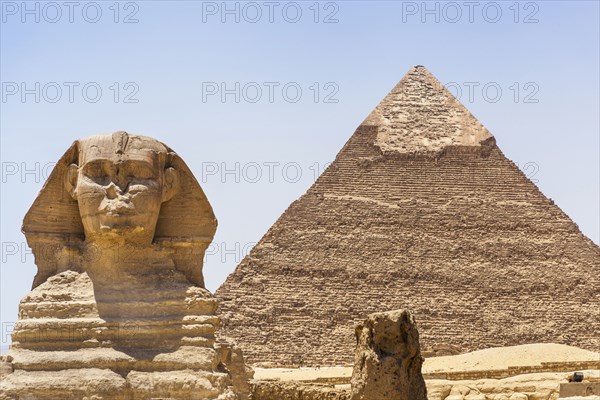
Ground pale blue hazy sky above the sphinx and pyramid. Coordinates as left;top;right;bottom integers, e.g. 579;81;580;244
0;1;600;349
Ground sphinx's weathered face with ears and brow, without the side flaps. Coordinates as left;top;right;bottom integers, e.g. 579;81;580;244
65;132;179;244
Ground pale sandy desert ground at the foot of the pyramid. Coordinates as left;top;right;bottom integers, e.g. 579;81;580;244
254;343;600;400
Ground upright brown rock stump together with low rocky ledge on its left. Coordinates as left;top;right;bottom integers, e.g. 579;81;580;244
251;310;427;400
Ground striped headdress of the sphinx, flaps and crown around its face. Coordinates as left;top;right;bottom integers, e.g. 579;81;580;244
22;132;217;288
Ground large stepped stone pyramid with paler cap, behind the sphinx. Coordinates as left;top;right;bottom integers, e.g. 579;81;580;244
216;66;600;365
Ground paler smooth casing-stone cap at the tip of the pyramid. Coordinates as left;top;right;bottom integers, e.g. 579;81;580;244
361;65;493;153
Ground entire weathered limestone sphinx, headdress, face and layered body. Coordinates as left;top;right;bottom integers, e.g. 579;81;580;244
0;132;248;400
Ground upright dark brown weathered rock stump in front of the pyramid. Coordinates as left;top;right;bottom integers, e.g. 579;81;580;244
352;310;428;400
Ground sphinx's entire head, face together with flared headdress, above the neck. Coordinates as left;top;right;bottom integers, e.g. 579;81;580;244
22;132;217;287
